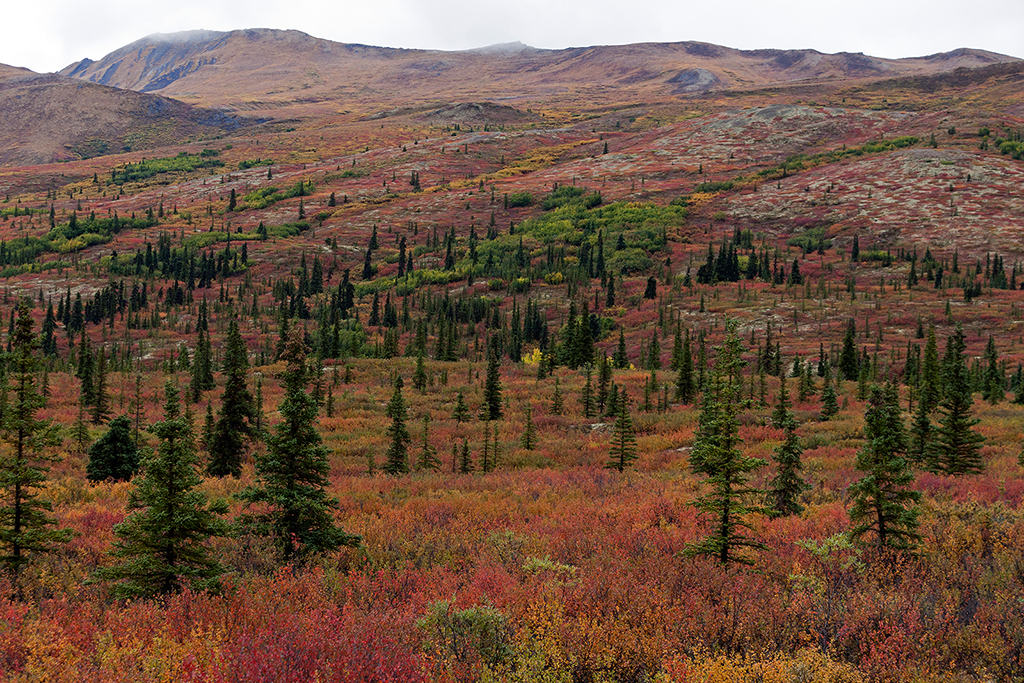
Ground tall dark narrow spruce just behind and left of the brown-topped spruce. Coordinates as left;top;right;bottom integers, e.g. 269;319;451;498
207;321;254;477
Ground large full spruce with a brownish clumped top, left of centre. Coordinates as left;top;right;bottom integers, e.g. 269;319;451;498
241;331;360;562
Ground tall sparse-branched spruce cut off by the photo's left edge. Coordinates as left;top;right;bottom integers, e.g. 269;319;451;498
0;301;71;591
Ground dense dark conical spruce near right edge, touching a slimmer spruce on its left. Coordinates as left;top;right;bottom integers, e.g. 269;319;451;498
928;324;985;474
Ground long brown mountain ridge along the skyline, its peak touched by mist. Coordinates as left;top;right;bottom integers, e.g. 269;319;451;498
61;29;1016;116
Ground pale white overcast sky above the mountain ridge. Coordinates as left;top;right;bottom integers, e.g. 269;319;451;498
0;0;1024;72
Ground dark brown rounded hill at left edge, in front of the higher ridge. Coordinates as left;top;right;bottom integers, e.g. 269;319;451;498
0;66;260;166
